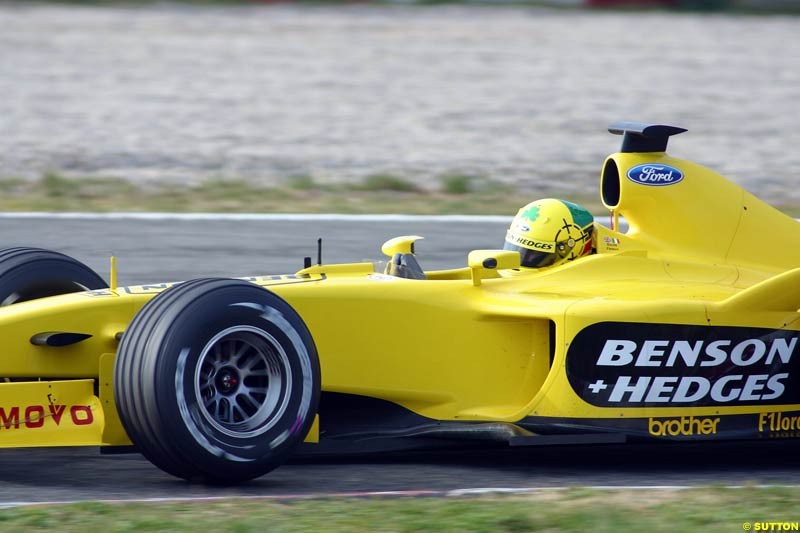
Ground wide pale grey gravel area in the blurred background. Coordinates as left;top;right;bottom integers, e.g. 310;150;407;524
0;3;800;202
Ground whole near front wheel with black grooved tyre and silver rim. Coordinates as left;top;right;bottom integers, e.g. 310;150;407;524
114;279;320;484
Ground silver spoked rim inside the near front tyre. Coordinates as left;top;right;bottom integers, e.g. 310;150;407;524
194;326;292;438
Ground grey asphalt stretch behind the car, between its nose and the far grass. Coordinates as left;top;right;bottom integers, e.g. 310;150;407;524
0;214;512;285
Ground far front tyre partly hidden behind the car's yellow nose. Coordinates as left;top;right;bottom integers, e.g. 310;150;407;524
0;248;108;306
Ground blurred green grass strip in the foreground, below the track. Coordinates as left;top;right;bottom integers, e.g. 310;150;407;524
0;487;800;533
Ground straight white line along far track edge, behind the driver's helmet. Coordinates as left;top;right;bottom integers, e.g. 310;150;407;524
0;211;513;224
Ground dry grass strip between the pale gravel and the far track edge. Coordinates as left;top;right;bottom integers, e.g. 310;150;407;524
0;174;602;216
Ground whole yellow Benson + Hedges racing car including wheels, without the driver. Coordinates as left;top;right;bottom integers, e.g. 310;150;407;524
0;123;800;482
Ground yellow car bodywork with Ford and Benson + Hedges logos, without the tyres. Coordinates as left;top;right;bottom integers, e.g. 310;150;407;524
0;123;800;480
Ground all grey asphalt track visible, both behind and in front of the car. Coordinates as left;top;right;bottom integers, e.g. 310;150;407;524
0;218;800;507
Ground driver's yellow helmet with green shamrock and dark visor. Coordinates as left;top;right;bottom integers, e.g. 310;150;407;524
503;198;594;268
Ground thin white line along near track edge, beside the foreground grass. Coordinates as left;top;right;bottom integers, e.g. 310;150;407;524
0;485;800;510
